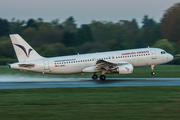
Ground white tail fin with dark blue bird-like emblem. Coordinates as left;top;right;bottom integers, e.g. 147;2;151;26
10;34;43;62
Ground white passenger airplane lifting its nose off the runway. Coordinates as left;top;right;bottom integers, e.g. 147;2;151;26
9;34;173;80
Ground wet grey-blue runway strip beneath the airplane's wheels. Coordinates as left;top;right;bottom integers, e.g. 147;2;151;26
0;77;180;89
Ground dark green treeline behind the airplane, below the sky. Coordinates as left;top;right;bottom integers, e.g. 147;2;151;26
0;3;180;64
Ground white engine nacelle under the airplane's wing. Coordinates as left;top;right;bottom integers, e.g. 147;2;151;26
117;64;134;74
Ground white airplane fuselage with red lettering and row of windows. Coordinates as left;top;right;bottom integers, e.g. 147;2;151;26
10;48;173;74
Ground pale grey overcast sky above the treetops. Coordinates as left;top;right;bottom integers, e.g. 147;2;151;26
0;0;180;25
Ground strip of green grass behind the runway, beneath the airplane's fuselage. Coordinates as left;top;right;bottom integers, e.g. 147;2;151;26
0;65;180;78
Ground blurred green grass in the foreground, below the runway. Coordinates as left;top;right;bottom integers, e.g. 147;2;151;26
0;86;180;120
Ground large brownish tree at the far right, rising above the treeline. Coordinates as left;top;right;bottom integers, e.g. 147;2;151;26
161;3;180;45
